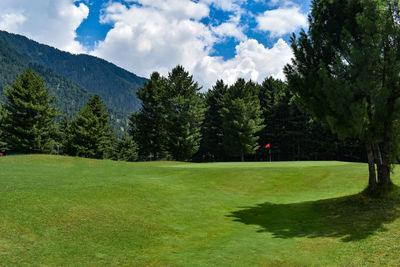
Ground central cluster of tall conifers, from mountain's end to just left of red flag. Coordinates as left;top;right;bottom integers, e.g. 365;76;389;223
130;66;263;163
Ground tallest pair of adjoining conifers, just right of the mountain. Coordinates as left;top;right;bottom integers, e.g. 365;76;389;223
130;66;205;161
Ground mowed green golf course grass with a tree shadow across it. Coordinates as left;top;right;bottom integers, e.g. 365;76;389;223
0;155;400;266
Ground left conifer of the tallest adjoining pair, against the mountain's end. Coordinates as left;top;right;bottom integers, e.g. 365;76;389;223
129;72;167;159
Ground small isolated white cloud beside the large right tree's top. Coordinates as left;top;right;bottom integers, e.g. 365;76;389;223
257;7;307;37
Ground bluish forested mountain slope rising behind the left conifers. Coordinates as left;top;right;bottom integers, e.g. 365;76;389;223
0;31;146;133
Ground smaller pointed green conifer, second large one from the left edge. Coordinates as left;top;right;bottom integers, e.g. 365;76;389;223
63;95;115;158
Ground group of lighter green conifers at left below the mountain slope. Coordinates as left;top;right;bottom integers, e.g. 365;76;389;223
0;69;137;161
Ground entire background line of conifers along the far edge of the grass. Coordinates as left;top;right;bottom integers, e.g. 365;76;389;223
0;66;365;162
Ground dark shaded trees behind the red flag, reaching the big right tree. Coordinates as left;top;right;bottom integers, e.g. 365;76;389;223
257;77;365;161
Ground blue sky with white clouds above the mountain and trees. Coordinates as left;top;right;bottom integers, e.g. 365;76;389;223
0;0;310;90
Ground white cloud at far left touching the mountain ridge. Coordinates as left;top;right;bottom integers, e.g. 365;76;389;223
0;0;89;53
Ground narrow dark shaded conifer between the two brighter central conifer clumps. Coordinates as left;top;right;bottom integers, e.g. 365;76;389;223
198;80;228;161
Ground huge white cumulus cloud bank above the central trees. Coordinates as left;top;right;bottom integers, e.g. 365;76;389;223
92;0;292;89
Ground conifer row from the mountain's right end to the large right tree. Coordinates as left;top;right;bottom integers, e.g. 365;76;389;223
129;66;364;161
